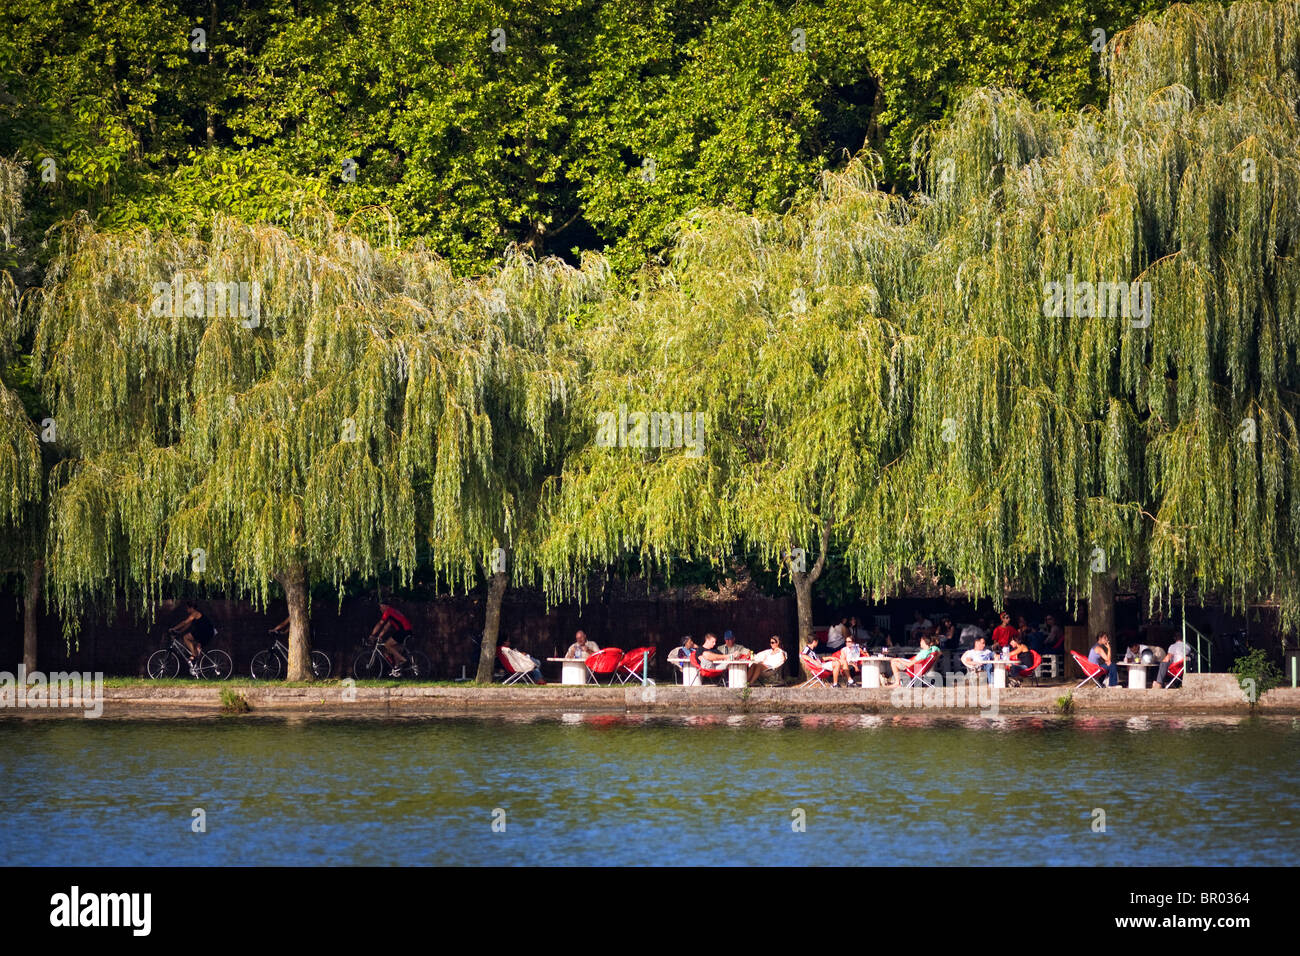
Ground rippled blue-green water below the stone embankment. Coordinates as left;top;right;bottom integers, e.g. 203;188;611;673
0;714;1300;866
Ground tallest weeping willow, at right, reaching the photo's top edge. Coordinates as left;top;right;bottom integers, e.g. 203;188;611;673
891;4;1300;624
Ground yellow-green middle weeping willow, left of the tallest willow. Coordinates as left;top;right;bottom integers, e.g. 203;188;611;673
545;163;918;650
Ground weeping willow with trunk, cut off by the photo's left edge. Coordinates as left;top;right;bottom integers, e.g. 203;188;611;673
0;159;46;670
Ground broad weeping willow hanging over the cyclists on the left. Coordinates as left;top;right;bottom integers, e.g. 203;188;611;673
34;213;599;680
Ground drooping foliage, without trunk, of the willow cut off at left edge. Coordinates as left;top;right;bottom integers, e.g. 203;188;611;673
0;159;44;563
